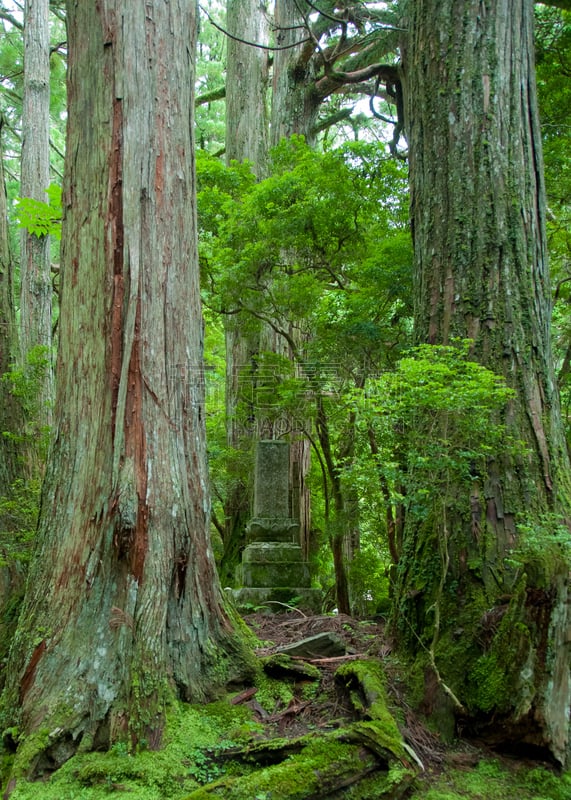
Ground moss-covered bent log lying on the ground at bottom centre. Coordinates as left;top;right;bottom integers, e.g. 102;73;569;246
182;661;421;800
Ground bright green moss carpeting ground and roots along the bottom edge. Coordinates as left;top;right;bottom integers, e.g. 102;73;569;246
4;680;571;800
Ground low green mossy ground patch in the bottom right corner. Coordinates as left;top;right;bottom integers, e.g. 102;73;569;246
409;759;571;800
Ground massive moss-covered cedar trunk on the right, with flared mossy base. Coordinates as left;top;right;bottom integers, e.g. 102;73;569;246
396;0;571;762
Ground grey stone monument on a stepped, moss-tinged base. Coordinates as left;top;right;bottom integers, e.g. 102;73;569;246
233;439;321;611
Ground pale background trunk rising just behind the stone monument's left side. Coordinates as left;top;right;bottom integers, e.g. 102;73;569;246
220;0;269;585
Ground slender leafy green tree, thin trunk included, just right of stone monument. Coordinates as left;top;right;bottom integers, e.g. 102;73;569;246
199;137;410;608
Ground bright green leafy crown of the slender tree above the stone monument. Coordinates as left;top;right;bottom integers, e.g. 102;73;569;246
197;137;411;350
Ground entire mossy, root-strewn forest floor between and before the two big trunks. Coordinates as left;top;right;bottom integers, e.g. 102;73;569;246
5;609;571;800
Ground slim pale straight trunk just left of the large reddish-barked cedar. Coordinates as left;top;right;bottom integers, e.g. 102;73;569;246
20;0;54;425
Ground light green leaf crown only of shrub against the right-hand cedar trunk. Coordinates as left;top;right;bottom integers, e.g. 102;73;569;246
362;340;517;518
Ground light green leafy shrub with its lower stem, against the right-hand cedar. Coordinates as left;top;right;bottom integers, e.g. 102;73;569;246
345;340;521;600
